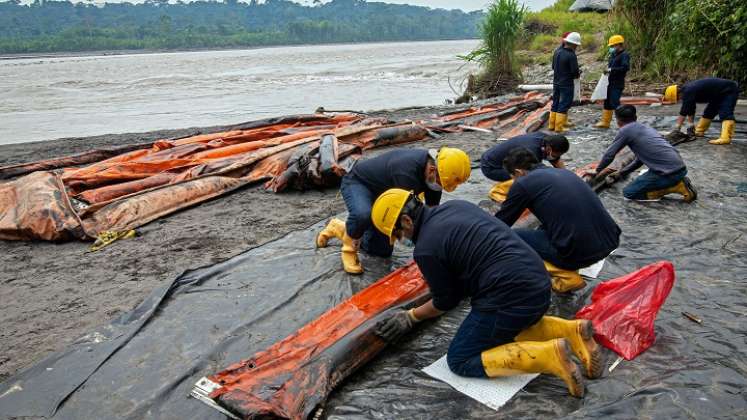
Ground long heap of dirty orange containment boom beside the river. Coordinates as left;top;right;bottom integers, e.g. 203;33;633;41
0;92;549;241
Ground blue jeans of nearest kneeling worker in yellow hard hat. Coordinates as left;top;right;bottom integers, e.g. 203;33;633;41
446;292;550;378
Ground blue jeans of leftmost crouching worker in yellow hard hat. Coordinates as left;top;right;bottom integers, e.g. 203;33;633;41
340;175;394;258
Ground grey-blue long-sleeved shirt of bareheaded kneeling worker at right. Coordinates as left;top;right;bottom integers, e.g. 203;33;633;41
597;121;685;175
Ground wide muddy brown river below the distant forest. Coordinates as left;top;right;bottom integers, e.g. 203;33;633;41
0;40;478;144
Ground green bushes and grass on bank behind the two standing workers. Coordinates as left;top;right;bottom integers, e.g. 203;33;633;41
460;0;747;101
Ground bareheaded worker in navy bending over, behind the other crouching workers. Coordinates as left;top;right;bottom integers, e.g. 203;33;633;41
480;131;569;202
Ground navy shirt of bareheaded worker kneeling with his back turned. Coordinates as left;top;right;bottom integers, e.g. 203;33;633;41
495;165;621;265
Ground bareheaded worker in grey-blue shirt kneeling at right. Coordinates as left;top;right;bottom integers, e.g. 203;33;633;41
590;105;698;203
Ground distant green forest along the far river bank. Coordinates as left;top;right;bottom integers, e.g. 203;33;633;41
0;0;483;54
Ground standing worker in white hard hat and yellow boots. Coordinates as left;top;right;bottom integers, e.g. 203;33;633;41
548;32;581;133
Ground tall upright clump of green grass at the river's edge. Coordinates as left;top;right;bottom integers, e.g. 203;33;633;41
461;0;527;93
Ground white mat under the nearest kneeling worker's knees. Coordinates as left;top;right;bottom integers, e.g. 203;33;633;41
423;355;538;410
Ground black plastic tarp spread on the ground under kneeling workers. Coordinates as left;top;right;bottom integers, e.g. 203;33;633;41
0;115;747;419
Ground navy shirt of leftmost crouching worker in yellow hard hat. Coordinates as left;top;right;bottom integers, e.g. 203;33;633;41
350;149;441;206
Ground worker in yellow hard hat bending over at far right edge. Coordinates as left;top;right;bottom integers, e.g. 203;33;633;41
664;77;739;144
